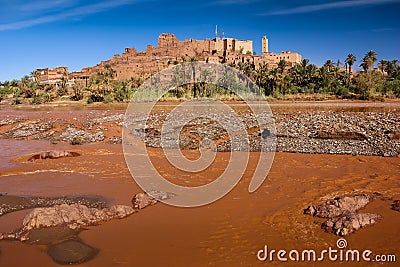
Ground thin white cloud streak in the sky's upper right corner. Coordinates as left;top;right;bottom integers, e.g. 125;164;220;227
260;0;400;16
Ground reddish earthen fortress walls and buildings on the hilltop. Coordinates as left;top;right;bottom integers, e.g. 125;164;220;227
62;33;301;82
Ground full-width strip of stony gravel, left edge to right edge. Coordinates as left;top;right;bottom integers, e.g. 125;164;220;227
0;110;400;157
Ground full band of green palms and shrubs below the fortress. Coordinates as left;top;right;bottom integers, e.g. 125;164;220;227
0;50;400;104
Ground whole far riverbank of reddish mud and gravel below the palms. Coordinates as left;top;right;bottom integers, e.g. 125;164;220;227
0;101;400;157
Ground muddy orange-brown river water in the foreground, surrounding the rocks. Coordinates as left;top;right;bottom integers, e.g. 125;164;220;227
0;139;400;266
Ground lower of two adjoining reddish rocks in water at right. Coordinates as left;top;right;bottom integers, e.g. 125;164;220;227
321;213;381;236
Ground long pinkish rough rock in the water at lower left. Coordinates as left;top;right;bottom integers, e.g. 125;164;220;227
22;204;135;232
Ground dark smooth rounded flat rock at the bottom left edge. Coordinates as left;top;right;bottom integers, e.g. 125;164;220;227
47;240;99;265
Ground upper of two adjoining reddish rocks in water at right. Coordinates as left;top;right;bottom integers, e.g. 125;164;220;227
304;194;371;218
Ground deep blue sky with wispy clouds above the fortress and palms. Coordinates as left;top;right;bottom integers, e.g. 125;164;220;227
0;0;400;81
